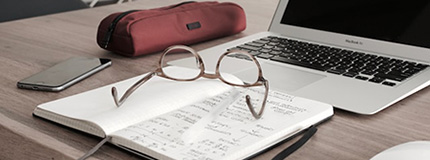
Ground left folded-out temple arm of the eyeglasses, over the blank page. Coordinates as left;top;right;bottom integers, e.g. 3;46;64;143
112;72;156;107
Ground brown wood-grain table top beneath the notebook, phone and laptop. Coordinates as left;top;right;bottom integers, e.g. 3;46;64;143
0;0;430;159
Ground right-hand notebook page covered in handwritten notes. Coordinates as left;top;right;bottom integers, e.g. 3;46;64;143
112;91;333;159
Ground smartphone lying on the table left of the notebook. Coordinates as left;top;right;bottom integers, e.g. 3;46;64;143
17;57;112;92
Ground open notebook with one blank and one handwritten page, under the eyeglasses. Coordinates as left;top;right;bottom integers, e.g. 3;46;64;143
33;67;333;159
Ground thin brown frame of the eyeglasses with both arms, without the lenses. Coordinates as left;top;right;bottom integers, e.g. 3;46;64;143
111;45;269;119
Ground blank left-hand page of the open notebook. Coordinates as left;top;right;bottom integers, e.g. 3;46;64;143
35;67;237;135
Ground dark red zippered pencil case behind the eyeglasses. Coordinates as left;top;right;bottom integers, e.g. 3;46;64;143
97;2;246;57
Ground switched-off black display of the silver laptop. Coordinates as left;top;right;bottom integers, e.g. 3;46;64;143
281;0;430;48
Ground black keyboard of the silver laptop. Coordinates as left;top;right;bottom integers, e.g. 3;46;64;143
231;36;428;86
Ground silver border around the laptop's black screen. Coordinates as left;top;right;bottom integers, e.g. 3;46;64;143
269;0;430;63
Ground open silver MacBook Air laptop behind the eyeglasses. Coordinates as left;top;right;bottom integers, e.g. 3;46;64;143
170;0;430;115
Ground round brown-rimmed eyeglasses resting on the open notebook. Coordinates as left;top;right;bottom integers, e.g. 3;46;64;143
112;45;269;119
